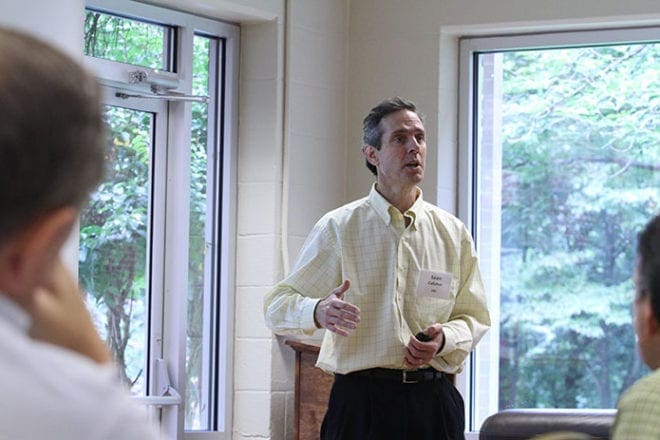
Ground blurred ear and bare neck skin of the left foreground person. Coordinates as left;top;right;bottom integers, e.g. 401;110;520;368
0;206;78;299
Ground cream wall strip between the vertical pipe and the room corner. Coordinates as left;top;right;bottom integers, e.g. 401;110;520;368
286;0;348;254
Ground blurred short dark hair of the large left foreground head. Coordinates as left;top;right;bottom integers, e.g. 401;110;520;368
0;28;104;244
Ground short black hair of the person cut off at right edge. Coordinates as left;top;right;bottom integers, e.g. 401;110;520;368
637;215;660;321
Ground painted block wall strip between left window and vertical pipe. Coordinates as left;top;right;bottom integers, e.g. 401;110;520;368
233;12;286;439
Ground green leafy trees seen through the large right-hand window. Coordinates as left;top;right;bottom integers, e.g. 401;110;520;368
500;44;660;408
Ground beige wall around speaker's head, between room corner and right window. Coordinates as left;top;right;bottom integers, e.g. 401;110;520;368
347;0;441;205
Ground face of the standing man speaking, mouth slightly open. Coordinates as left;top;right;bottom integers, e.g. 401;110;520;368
367;110;426;188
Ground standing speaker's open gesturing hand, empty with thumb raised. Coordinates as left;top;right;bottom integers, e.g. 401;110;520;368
314;280;360;336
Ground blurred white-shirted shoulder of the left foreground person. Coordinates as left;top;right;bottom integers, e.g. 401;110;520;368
0;322;154;439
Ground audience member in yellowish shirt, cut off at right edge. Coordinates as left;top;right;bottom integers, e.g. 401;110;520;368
612;215;660;440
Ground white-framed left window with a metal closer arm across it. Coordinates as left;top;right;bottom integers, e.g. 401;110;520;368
79;1;238;438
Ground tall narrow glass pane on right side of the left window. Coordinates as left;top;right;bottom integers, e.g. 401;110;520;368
185;36;215;430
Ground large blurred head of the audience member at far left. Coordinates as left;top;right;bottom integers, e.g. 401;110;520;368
0;29;103;299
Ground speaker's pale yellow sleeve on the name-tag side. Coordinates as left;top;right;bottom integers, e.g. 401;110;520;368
436;226;490;372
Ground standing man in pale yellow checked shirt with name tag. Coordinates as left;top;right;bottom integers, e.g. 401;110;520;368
264;98;490;440
